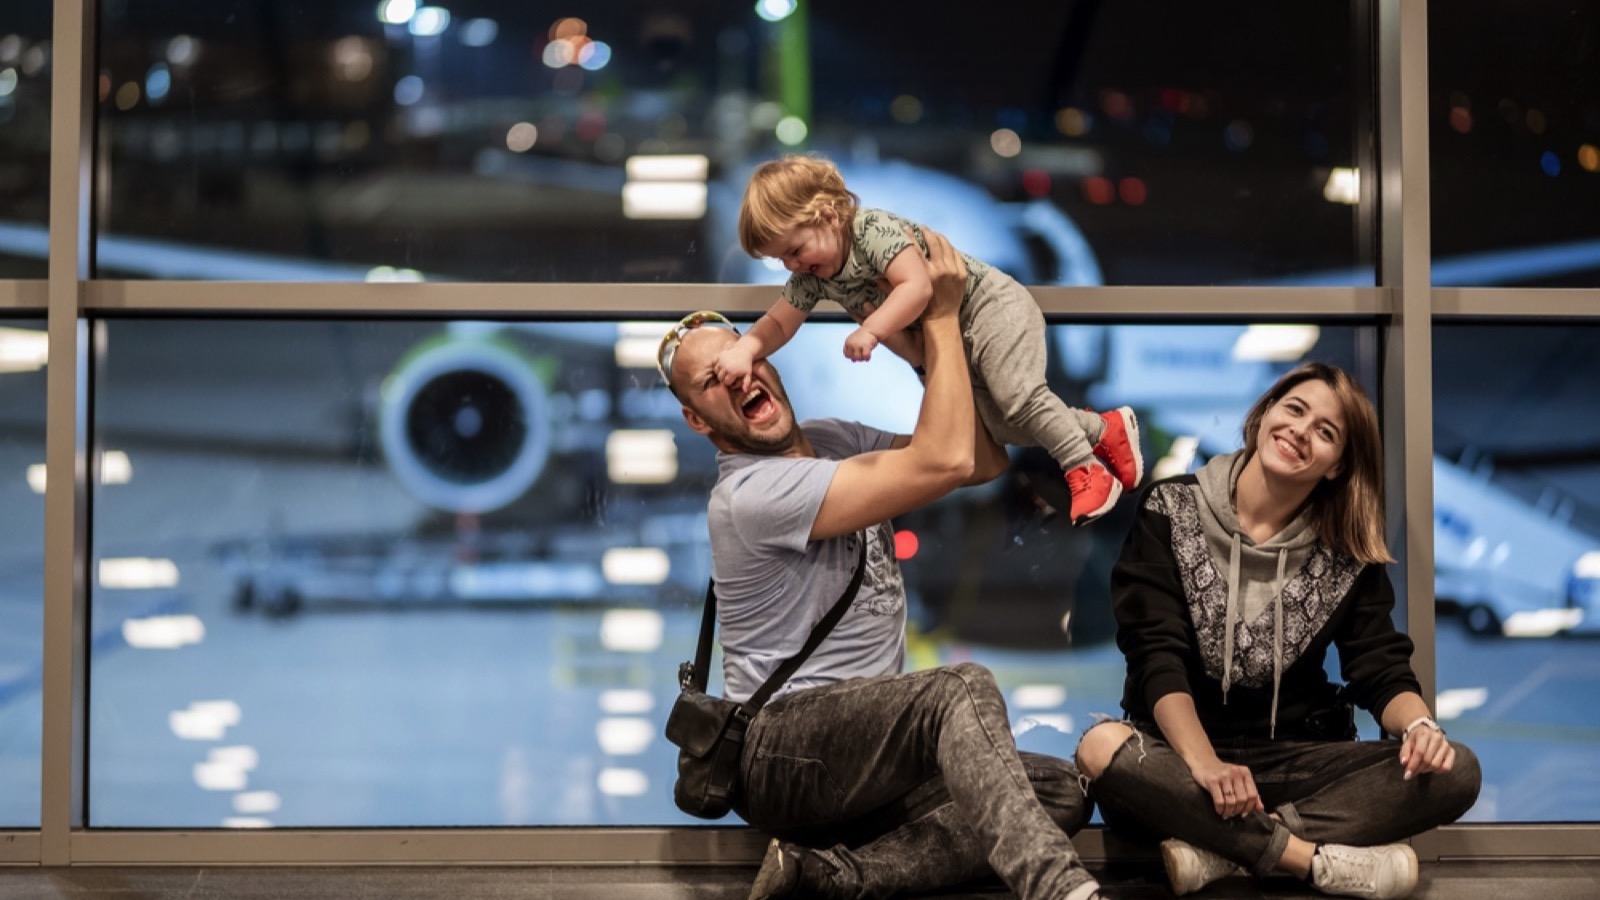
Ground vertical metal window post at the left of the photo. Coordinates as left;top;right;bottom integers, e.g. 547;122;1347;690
38;0;94;865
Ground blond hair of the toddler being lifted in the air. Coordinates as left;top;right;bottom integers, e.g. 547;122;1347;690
739;155;861;259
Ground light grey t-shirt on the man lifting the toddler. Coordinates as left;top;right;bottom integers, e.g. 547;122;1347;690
707;420;906;703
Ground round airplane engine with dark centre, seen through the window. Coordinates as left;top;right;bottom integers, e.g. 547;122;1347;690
378;338;550;512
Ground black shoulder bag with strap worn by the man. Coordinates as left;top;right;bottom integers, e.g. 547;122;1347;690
666;533;867;818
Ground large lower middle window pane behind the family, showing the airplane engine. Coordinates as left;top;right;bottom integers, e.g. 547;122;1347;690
88;312;1371;828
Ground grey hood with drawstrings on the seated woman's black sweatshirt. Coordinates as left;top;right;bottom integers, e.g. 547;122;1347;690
1195;450;1317;732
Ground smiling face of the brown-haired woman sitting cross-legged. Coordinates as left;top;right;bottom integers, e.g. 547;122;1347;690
1256;378;1346;487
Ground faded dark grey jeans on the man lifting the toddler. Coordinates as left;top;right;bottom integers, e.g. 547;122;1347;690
736;663;1091;900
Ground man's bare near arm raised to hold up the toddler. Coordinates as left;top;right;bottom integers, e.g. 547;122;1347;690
811;231;979;540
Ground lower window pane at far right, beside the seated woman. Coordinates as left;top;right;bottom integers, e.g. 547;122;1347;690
1434;322;1600;822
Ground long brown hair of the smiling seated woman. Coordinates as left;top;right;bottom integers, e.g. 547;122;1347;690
1245;362;1394;564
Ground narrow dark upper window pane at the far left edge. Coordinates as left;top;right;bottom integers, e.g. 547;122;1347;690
0;0;51;279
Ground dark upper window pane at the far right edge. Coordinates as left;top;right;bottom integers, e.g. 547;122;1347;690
1427;0;1600;281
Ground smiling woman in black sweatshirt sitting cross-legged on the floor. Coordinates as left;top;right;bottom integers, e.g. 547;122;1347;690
1078;364;1480;897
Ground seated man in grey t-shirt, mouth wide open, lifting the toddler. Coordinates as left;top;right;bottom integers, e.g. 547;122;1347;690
658;232;1099;900
